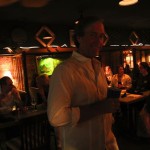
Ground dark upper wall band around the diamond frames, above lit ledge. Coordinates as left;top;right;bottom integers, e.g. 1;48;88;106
0;22;150;49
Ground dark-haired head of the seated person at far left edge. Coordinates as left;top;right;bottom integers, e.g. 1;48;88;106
0;76;14;93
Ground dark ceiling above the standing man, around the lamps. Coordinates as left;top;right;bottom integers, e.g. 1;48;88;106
0;0;150;28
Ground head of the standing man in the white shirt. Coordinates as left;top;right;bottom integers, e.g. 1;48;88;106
74;16;105;58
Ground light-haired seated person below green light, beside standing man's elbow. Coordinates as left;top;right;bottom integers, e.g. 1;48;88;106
36;74;50;102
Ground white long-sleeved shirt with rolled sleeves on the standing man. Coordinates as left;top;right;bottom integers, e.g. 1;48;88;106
47;51;118;150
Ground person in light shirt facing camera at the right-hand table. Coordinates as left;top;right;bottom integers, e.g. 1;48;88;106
110;66;132;89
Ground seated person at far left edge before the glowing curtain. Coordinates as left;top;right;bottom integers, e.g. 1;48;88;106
0;76;22;107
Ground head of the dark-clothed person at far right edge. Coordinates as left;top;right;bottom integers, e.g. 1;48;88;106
139;62;150;76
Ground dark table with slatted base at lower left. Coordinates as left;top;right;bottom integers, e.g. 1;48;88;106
0;106;55;150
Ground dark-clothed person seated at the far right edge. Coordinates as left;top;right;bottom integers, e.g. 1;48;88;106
133;62;150;93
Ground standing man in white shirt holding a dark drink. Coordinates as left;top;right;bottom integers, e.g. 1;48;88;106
47;17;119;150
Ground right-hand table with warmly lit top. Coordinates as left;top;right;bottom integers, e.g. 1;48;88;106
119;91;150;133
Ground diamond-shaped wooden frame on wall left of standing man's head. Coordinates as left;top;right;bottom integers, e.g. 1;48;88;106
36;26;55;47
